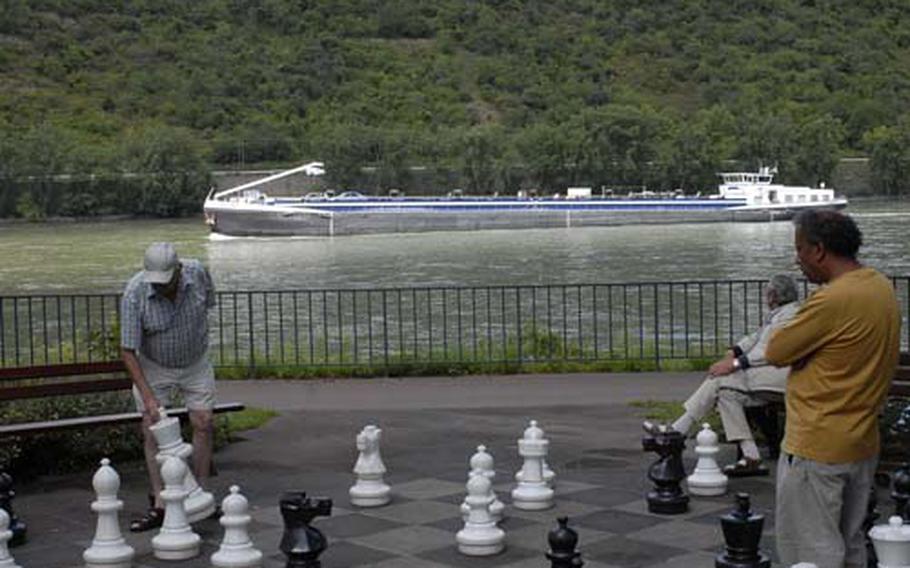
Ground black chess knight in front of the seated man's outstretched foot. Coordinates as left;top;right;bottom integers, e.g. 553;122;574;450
642;429;689;515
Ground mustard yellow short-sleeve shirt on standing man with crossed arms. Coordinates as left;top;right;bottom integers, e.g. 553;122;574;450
765;268;901;463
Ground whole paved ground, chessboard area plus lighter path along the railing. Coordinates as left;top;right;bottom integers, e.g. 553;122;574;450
13;373;792;568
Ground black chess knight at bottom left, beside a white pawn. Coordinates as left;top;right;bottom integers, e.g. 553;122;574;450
279;491;332;568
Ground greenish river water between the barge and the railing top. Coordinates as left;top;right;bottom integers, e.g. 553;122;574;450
0;201;910;295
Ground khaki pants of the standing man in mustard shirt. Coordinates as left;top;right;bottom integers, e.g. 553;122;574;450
774;452;878;568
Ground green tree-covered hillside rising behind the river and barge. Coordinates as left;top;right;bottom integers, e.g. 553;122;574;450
0;0;910;216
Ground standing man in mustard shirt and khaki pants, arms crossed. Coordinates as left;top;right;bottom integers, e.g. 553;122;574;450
765;210;901;568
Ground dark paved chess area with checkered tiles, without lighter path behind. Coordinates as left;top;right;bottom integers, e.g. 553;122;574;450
13;407;792;568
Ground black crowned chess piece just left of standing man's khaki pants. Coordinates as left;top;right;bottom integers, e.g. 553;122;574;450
714;493;771;568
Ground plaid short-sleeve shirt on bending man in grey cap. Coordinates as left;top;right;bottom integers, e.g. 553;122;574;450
120;259;215;368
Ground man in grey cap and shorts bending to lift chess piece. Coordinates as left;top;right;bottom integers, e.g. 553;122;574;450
120;243;215;532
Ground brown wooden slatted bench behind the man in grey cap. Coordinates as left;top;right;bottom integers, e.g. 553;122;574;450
0;361;244;438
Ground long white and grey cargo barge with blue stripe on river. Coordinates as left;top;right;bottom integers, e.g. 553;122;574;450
204;162;847;237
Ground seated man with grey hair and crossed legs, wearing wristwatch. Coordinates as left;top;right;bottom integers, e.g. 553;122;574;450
643;274;799;477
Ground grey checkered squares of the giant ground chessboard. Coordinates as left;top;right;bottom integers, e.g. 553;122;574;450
14;458;774;568
